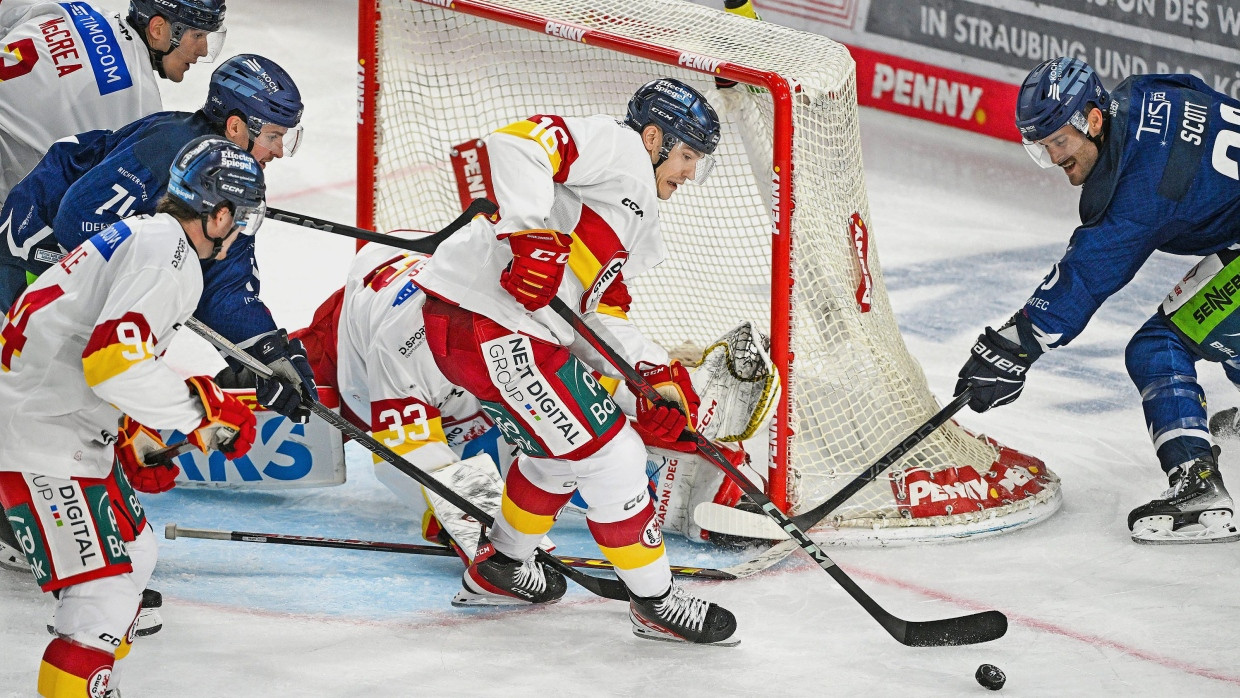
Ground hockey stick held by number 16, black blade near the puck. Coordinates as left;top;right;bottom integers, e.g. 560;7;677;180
551;298;1007;647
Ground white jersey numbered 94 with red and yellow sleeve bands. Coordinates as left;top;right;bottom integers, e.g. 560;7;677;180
0;213;205;479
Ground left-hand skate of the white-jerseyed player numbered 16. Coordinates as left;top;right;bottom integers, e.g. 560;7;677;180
453;537;568;606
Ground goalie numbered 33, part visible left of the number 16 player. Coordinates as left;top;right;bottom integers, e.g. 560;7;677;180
291;238;507;562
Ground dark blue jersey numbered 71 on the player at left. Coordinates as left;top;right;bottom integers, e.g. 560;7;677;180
0;112;275;346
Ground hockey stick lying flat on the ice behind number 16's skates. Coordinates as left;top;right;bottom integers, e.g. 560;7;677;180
164;523;737;579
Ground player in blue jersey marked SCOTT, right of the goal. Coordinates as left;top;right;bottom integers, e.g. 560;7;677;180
956;58;1240;543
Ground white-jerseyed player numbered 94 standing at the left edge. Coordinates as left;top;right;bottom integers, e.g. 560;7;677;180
0;136;264;698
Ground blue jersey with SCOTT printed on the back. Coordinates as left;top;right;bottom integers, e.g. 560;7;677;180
1024;74;1240;350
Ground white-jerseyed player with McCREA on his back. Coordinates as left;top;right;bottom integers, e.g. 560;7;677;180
0;0;226;203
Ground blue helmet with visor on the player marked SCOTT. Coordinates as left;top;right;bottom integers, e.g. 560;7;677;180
1016;56;1111;166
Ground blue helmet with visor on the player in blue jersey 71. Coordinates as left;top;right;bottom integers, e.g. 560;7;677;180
202;53;303;156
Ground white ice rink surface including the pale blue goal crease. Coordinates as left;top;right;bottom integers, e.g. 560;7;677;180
0;0;1240;698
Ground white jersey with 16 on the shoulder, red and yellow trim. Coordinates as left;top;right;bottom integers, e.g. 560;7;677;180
415;115;667;360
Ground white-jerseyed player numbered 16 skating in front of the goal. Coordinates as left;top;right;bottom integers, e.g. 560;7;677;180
413;78;737;645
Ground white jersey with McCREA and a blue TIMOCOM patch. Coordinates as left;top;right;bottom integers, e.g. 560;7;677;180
0;0;164;201
